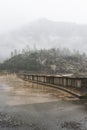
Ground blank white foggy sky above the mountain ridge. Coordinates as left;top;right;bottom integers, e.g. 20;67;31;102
0;0;87;33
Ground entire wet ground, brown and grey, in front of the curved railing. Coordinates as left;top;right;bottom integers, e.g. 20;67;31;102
0;75;87;130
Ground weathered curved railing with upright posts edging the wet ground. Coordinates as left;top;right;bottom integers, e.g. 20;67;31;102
17;73;87;97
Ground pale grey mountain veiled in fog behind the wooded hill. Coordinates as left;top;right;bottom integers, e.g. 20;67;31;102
0;19;87;57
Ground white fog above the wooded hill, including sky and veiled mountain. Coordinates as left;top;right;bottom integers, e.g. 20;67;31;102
0;0;87;59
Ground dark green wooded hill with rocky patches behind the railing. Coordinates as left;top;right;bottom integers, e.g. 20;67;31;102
0;48;87;74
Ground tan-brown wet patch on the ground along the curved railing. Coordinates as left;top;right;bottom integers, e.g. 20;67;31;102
0;75;76;105
